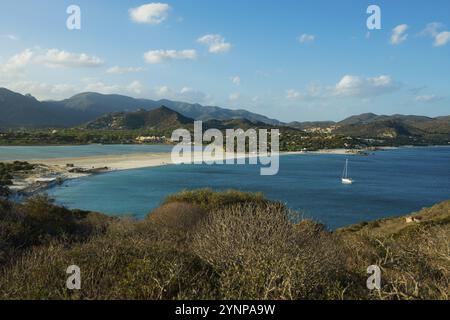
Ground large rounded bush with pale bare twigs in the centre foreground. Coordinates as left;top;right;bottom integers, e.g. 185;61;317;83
191;204;348;299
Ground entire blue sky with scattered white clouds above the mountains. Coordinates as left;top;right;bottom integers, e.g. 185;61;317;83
0;0;450;121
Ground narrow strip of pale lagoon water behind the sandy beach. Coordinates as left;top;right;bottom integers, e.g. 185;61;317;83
0;144;172;161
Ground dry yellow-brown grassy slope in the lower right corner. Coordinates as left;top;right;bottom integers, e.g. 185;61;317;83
338;201;450;300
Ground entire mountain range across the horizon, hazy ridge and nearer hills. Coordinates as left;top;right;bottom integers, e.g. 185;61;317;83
0;88;450;140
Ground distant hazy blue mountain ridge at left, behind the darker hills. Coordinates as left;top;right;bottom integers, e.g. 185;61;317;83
0;88;280;129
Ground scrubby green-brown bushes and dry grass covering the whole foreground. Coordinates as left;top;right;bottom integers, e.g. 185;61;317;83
0;190;450;299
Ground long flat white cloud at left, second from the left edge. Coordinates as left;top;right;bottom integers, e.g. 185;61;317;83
35;49;103;68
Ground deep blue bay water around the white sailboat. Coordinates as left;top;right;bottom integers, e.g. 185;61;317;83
39;146;450;229
